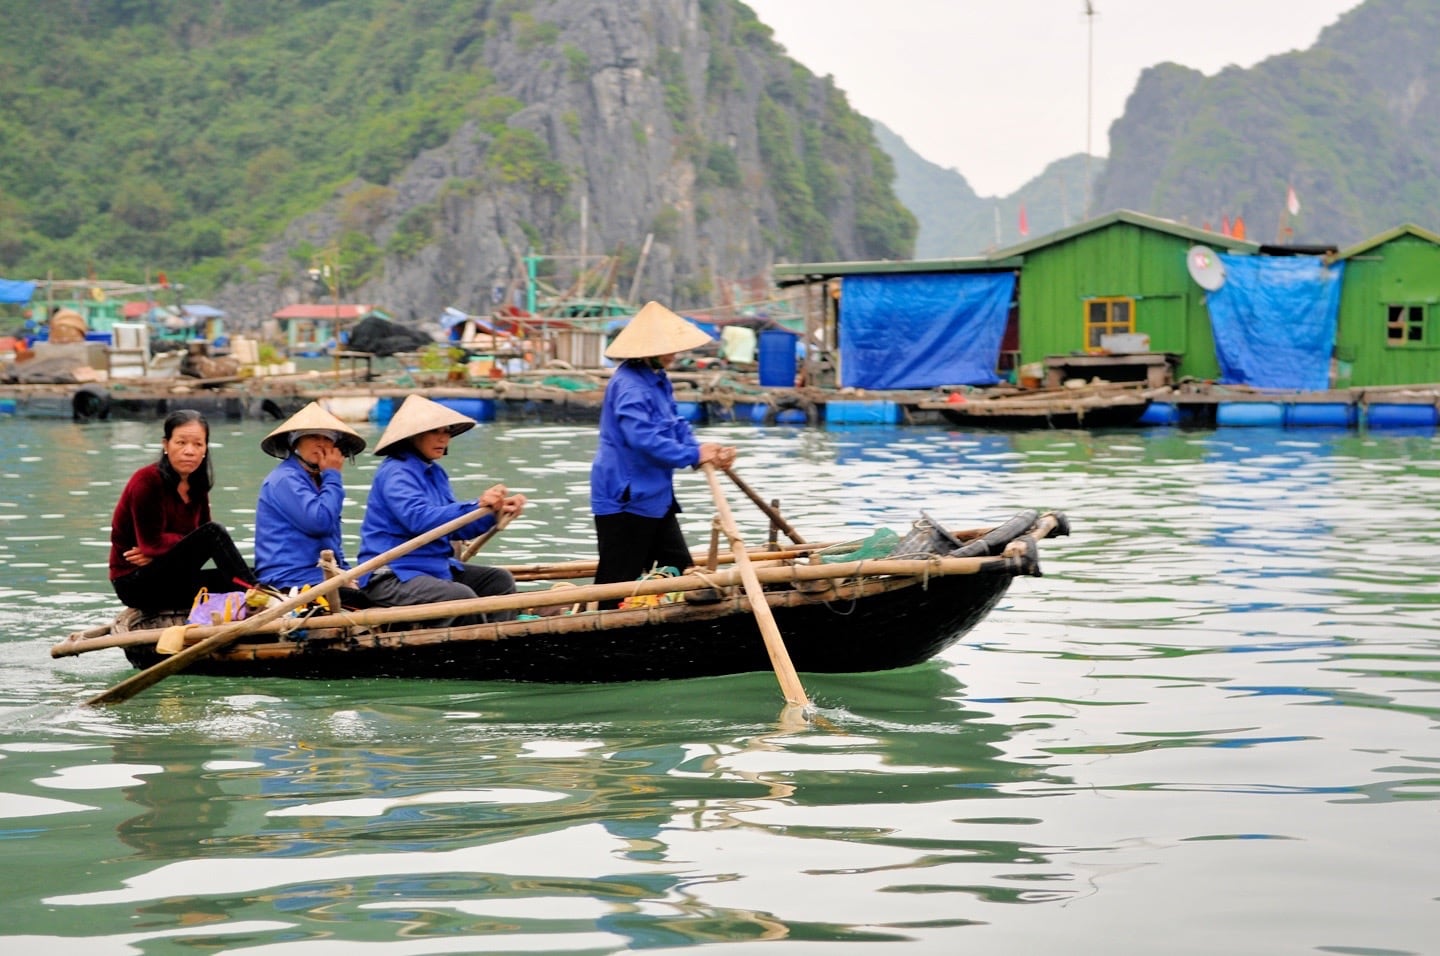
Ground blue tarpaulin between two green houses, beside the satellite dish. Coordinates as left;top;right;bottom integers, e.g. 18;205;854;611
1205;255;1345;392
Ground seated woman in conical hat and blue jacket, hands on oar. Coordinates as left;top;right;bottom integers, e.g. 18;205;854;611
359;394;526;626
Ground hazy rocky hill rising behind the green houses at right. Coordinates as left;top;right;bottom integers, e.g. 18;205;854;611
1099;0;1440;245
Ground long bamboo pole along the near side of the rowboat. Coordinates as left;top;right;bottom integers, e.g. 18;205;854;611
50;556;1021;658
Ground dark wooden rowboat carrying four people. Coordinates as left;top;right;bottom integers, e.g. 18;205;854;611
50;511;1068;682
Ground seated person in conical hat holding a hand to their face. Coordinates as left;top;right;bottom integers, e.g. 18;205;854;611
255;402;366;606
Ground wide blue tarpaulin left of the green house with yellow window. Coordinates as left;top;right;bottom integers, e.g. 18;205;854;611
840;272;1015;389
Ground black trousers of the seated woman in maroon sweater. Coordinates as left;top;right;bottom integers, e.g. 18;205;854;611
111;521;255;610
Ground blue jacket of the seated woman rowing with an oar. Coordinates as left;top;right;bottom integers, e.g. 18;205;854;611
356;449;495;587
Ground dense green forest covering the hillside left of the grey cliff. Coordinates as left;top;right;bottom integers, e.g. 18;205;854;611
0;0;512;282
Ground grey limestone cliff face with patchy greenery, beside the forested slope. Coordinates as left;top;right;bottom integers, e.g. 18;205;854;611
217;0;914;325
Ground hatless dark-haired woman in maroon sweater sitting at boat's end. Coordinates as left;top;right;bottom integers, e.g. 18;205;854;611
109;409;255;610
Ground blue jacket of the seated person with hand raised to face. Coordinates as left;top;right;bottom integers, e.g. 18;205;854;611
255;455;348;587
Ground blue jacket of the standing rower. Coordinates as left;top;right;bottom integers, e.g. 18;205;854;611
590;361;700;518
